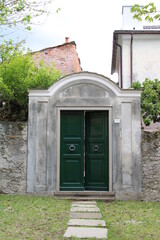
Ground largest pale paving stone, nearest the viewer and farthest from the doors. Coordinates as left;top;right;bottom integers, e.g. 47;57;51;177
64;227;108;239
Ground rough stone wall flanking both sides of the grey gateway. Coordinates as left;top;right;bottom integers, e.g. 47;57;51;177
0;122;160;201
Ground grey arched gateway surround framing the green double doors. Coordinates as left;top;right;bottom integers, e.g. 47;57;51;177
27;72;141;195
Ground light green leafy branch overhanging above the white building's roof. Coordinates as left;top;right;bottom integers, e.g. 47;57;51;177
131;2;160;22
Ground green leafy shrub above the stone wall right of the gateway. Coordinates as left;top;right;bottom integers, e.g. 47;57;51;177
132;78;160;126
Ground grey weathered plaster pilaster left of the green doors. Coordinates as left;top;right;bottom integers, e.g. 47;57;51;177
27;98;51;192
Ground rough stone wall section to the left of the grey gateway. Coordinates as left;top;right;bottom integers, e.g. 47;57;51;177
0;122;27;194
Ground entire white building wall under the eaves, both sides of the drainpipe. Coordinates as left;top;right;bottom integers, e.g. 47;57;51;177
119;34;160;89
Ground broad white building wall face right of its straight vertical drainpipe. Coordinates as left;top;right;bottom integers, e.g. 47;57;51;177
133;34;160;83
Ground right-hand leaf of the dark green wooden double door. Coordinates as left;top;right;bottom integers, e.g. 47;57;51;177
85;112;109;191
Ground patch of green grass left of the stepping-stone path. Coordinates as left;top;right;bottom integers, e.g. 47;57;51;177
0;195;71;240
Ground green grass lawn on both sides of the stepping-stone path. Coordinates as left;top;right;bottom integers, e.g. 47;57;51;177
0;195;160;240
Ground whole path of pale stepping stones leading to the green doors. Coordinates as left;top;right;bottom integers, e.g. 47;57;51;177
64;201;108;239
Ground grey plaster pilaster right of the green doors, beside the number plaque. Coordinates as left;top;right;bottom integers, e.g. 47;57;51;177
113;99;141;194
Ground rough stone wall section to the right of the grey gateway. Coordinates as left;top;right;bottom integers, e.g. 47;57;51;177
142;131;160;201
